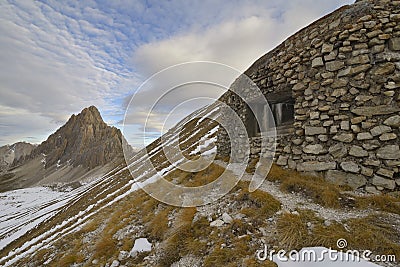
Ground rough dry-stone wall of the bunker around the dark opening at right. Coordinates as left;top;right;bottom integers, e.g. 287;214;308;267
217;0;400;192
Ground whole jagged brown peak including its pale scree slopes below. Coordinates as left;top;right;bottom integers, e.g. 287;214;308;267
0;106;123;191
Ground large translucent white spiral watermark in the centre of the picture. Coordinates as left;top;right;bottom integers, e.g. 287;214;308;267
123;61;276;207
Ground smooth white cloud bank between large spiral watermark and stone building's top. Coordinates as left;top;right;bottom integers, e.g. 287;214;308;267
133;0;350;76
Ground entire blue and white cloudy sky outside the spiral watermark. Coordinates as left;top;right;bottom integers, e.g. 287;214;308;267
0;0;354;148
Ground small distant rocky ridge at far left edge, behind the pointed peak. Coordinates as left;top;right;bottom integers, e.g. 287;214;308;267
0;142;35;172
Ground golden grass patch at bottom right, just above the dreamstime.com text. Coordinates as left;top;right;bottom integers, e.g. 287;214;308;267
277;211;400;257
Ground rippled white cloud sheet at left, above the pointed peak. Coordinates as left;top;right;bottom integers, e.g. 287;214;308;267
0;1;140;145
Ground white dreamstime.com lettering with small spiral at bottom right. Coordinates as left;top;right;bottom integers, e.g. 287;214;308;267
256;238;396;263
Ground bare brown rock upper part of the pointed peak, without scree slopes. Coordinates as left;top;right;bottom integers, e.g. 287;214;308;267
27;106;122;169
